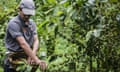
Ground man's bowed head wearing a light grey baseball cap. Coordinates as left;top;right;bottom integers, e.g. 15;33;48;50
19;0;35;21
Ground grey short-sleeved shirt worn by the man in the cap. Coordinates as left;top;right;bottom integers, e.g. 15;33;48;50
5;15;37;52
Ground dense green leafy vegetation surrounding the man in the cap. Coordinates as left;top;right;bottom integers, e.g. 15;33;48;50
0;0;120;72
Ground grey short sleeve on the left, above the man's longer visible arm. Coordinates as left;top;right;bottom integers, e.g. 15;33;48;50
8;22;22;38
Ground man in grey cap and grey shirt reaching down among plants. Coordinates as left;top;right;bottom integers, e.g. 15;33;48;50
4;0;47;72
